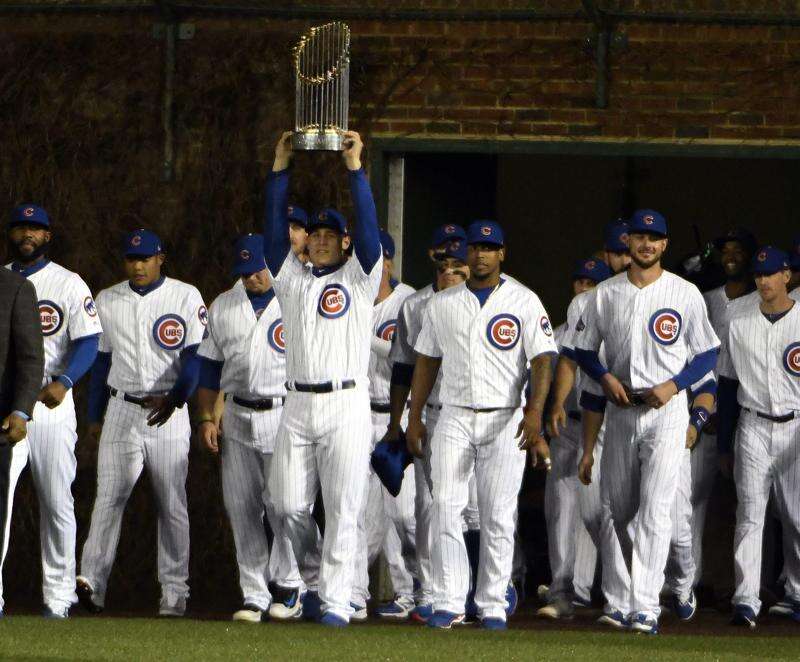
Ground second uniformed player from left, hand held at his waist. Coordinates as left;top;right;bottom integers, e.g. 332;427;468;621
77;229;208;616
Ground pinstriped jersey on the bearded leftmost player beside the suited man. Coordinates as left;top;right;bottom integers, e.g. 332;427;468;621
6;262;103;383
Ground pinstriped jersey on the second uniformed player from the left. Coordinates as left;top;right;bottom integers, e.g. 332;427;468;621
97;278;208;395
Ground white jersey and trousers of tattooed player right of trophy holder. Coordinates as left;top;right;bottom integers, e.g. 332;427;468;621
415;280;557;620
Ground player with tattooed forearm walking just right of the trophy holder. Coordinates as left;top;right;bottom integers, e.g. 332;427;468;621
406;221;556;629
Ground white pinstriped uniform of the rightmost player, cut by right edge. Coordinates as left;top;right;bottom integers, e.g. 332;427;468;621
719;302;800;614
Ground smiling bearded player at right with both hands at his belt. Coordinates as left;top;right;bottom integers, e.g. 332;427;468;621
576;210;719;633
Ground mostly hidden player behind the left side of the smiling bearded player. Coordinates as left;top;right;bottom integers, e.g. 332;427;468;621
537;258;611;619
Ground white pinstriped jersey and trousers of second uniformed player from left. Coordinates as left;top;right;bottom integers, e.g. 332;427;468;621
81;278;208;606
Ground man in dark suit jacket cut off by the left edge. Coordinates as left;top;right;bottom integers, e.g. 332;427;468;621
0;269;44;615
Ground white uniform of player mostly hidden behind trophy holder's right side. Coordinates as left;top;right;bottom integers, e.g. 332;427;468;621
353;283;417;607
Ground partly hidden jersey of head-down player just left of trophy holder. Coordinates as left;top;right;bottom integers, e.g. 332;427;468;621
197;281;286;400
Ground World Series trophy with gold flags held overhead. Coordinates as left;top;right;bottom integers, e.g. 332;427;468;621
292;21;350;151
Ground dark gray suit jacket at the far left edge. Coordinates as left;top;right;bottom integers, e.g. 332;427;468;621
0;267;44;419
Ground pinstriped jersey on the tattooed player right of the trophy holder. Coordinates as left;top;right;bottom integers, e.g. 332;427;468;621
415;280;557;408
